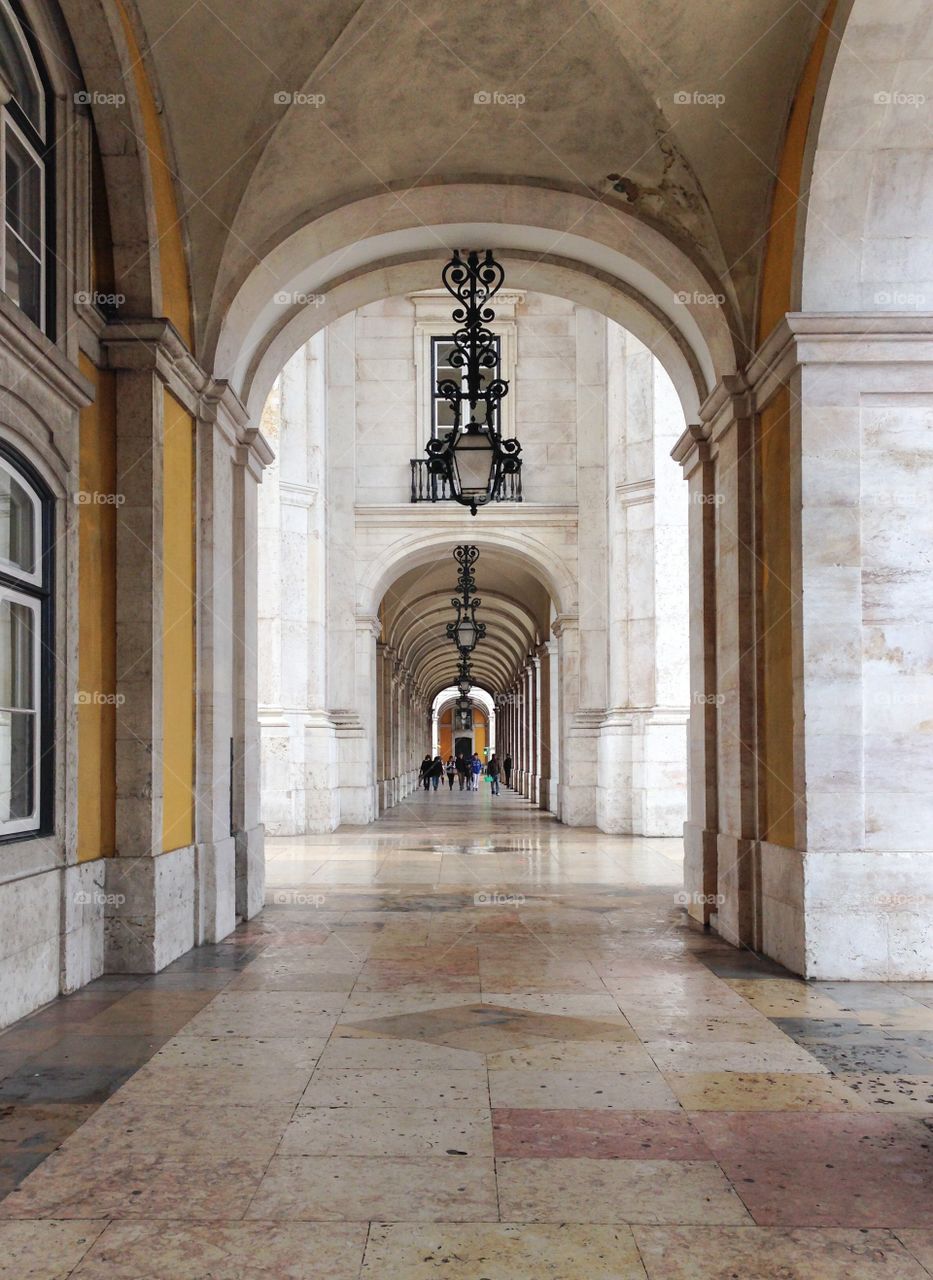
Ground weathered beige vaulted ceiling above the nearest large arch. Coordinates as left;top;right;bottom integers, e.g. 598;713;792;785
127;0;818;350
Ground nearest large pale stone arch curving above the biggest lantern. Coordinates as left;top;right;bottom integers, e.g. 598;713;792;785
209;184;740;417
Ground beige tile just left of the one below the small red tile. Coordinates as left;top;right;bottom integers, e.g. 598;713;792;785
244;1156;499;1222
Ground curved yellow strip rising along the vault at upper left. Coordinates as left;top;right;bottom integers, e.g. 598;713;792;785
115;0;193;351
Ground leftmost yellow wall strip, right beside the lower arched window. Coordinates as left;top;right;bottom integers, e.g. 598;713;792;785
78;356;116;863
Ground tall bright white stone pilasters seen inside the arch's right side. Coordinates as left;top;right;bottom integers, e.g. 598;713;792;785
598;325;690;836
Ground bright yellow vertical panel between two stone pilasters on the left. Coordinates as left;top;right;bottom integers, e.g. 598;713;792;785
163;392;196;851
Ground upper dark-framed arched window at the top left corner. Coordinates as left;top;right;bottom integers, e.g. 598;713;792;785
0;0;52;332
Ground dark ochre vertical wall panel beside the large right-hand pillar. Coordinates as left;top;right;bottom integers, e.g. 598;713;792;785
755;387;795;847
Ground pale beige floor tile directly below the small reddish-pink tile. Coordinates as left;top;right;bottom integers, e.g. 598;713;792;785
497;1158;750;1225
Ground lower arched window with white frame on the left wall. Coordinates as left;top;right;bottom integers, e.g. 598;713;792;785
0;442;54;840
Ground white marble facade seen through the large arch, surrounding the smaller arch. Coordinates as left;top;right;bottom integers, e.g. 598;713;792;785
260;293;686;835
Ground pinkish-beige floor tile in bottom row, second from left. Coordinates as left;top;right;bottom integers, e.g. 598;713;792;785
70;1222;366;1280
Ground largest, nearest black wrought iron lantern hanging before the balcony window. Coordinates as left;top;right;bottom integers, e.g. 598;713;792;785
412;250;522;516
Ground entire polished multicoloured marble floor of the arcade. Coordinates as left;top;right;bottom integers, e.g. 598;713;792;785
0;788;933;1280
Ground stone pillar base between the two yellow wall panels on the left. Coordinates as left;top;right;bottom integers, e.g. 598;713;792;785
104;845;197;973
